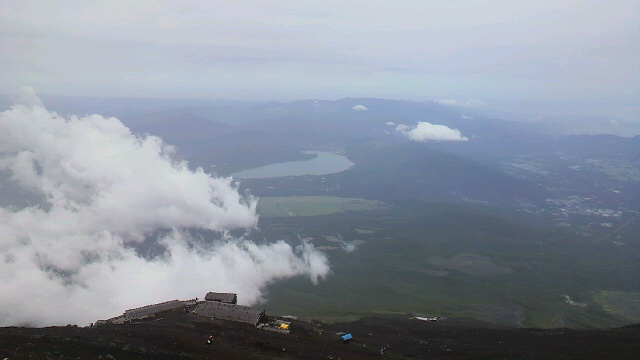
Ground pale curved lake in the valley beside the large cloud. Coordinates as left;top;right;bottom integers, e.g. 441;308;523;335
231;151;353;179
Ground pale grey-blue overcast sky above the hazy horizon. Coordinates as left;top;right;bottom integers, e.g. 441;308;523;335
0;0;640;117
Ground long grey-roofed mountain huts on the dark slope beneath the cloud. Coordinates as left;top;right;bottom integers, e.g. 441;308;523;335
96;292;266;326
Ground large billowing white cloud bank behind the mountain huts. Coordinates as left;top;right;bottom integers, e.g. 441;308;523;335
0;89;329;326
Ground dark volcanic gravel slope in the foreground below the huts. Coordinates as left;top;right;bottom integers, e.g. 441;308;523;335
0;312;640;360
